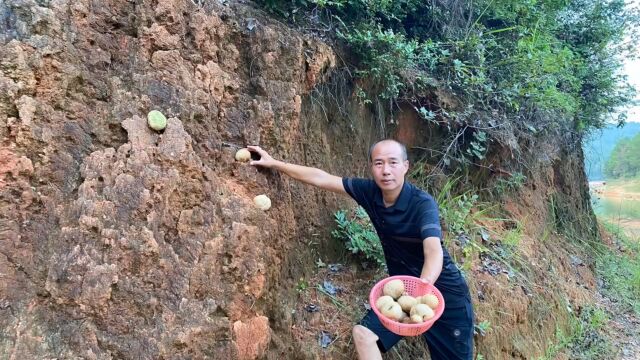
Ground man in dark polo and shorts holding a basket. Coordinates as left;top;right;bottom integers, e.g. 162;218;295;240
248;140;473;360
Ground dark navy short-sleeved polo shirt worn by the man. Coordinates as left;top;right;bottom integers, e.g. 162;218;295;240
342;178;470;307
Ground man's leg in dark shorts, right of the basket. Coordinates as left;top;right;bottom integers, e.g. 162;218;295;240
424;302;473;360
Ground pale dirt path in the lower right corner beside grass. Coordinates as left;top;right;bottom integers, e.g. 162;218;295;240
597;293;640;360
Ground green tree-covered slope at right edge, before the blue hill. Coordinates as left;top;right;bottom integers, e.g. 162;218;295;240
604;134;640;179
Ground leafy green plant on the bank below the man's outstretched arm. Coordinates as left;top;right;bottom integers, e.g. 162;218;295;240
331;206;385;266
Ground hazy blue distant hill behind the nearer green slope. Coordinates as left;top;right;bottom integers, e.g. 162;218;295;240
584;122;640;181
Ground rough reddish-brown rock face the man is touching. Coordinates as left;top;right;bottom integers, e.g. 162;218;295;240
0;0;366;359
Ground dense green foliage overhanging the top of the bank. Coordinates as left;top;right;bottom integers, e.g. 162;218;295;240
260;0;638;135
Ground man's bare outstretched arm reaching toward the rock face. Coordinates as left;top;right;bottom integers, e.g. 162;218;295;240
247;146;347;195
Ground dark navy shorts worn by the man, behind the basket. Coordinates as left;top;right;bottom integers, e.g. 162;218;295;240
360;301;473;360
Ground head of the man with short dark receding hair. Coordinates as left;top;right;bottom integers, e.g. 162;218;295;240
371;141;409;192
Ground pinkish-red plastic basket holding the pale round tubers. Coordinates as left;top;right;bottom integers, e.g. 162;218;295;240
369;275;444;336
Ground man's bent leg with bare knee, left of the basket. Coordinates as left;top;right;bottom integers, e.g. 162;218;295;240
353;310;402;360
